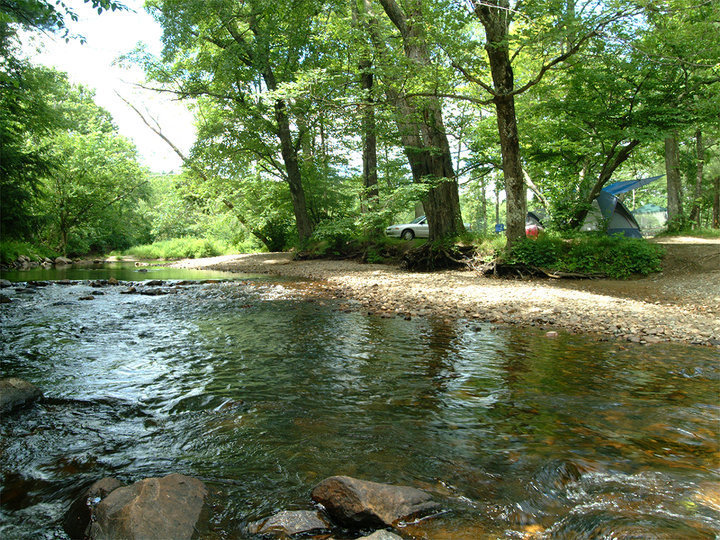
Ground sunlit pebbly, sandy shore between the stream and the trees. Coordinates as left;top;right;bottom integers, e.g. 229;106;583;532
173;239;720;349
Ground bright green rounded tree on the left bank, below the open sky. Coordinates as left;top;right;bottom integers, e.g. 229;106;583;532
36;79;148;252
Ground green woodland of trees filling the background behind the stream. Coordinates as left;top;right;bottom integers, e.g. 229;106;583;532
0;0;720;262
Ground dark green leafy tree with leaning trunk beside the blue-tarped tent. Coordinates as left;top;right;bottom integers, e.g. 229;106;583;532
523;31;679;229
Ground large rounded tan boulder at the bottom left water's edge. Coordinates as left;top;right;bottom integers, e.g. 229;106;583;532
88;474;207;540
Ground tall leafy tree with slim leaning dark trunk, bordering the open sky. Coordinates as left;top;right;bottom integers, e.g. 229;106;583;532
145;0;342;240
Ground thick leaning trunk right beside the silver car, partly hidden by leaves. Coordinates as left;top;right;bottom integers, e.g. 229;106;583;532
374;0;465;241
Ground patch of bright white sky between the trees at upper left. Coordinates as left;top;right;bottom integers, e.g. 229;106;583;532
23;0;195;172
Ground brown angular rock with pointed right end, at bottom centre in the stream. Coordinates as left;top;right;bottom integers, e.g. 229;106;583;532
311;476;440;528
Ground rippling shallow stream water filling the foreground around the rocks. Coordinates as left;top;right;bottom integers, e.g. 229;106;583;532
0;272;720;539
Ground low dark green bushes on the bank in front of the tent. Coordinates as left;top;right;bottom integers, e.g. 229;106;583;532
507;235;662;279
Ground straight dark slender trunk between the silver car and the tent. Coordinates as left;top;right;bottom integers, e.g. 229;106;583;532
474;0;527;245
